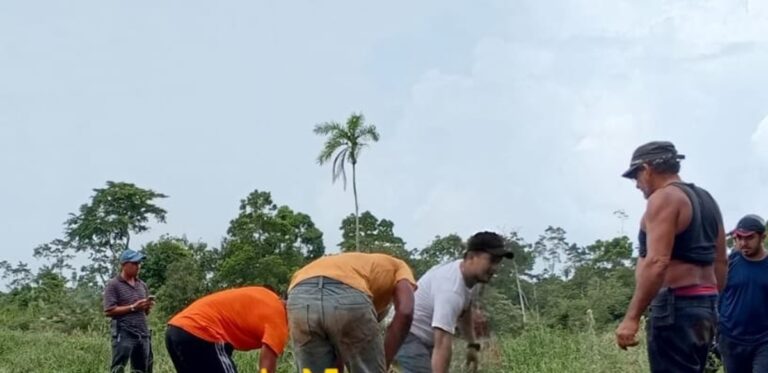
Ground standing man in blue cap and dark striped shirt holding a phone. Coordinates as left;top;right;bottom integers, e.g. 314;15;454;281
103;249;154;373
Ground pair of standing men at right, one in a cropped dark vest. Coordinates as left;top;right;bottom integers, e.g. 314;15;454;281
616;141;768;373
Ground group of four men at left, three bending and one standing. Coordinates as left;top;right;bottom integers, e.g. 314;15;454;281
104;231;513;373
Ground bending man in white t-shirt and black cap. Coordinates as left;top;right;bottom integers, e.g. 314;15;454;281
395;232;514;373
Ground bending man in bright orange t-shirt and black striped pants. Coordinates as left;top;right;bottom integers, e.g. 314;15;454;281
165;286;288;373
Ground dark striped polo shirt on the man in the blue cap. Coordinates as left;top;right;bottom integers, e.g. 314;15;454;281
103;275;149;336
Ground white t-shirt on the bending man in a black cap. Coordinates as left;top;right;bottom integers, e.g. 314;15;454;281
411;259;471;346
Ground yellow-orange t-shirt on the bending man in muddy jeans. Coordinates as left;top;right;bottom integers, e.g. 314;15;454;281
288;253;416;312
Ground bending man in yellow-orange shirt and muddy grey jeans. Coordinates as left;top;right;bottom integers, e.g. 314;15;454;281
288;253;416;373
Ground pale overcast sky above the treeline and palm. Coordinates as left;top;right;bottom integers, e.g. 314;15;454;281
0;0;768;268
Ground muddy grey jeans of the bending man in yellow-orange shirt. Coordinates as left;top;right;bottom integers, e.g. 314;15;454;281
287;277;386;373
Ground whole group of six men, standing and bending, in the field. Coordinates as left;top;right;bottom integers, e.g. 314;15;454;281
104;141;768;373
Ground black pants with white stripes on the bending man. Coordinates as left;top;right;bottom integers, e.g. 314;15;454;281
165;325;237;373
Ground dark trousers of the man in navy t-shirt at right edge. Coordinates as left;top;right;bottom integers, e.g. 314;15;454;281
718;334;768;373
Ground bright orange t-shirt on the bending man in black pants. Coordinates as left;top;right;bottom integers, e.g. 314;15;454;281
168;286;288;355
